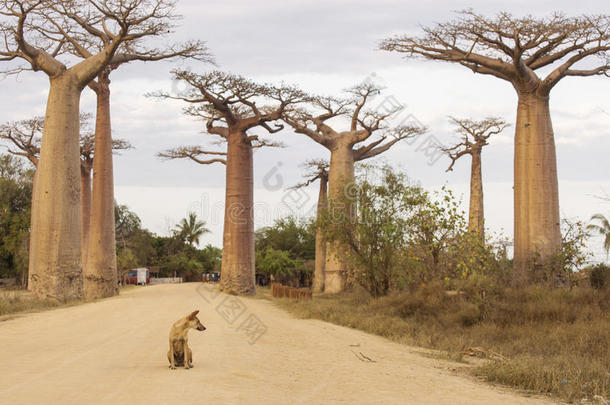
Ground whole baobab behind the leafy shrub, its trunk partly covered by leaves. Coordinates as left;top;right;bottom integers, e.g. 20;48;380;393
283;83;425;292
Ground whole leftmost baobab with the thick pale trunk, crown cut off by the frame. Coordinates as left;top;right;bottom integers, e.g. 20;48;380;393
0;0;189;301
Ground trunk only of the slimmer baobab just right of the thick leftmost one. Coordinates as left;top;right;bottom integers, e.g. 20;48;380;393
84;73;118;299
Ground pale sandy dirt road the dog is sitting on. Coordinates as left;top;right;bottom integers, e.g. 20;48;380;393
0;283;550;405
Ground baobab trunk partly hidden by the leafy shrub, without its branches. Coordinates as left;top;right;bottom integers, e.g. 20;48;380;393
324;143;355;293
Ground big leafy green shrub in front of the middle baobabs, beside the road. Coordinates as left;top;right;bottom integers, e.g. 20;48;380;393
321;166;508;297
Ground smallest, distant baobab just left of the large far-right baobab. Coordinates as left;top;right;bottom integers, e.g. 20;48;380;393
442;117;508;241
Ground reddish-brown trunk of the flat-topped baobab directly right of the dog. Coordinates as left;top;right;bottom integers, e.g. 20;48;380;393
220;132;255;294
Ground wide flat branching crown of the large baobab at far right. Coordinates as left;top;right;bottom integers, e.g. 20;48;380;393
380;10;610;94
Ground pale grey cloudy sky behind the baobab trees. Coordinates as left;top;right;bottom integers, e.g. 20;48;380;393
0;0;610;257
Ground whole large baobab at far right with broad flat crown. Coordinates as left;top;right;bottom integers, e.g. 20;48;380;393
380;10;610;284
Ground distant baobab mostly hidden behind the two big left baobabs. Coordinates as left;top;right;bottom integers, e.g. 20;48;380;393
0;114;132;263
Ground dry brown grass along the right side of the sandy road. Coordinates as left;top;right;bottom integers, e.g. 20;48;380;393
276;286;610;402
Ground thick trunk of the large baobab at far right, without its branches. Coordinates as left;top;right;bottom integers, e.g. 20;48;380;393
514;93;561;284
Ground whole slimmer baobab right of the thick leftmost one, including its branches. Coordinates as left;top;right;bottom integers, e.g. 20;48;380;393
47;0;211;298
